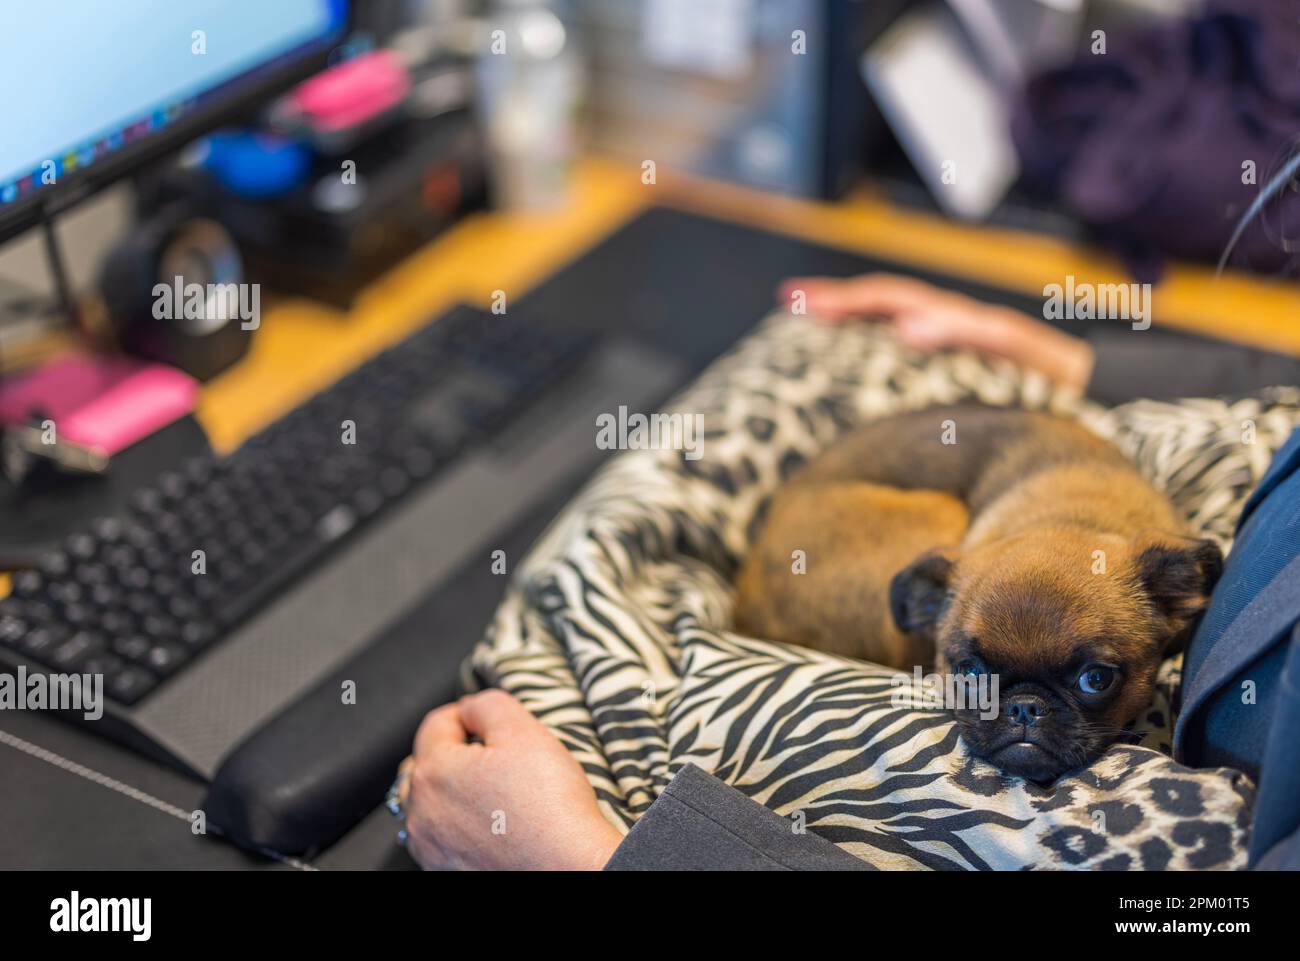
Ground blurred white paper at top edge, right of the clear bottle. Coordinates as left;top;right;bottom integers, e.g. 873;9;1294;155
641;0;754;79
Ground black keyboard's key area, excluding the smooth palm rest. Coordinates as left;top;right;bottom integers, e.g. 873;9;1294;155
0;309;593;706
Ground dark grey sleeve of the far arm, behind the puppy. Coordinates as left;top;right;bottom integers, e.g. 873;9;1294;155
1088;330;1300;404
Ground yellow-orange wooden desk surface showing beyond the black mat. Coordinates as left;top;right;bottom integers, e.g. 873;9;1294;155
199;159;1300;450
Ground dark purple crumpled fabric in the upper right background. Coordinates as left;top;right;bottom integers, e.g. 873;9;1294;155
1011;0;1300;280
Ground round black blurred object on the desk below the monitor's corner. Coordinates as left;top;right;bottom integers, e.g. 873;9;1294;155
100;203;254;380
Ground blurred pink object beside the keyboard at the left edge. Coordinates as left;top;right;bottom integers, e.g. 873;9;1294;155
0;355;199;456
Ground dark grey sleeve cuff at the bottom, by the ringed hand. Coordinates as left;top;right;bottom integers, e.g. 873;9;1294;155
605;765;872;871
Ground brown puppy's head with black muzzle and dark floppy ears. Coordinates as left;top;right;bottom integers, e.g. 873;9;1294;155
891;528;1223;782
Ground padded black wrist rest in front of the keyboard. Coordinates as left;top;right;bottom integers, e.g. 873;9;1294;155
203;476;585;857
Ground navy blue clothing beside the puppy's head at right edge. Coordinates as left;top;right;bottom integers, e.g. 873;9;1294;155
1174;430;1300;867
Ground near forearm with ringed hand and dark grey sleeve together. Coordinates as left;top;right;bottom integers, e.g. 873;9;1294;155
399;691;867;871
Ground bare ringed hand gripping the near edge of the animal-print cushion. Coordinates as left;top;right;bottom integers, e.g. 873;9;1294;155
399;691;623;870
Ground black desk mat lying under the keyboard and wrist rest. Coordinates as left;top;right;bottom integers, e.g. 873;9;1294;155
0;202;1274;870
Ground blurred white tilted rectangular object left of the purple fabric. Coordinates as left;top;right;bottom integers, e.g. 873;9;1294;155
862;8;1019;220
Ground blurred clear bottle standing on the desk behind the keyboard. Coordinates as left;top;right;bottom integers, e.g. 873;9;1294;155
480;0;582;211
